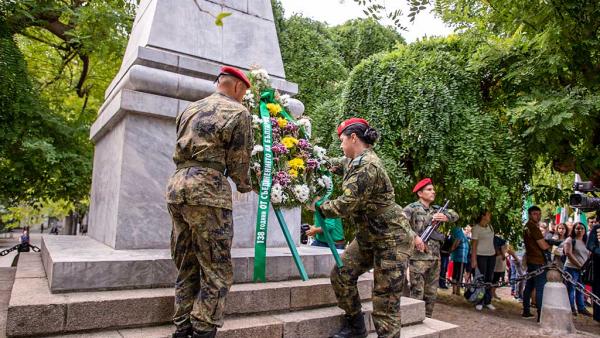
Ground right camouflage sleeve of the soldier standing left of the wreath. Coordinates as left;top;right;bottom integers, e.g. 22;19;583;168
225;111;253;193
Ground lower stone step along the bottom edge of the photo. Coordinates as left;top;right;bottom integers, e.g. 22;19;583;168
47;298;436;338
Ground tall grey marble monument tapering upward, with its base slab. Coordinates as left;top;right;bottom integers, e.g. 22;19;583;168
43;0;312;292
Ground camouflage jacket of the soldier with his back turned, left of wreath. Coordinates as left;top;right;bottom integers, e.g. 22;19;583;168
167;93;253;209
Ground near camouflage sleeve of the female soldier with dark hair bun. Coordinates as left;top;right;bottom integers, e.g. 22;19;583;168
320;164;377;218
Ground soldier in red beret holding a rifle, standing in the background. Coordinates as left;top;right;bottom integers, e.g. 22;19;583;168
404;178;458;318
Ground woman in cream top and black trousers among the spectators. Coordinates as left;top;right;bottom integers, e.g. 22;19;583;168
471;210;496;311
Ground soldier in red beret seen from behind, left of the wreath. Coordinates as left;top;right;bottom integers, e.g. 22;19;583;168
166;67;253;338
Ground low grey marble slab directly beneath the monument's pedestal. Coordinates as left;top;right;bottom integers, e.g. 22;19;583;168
42;235;335;293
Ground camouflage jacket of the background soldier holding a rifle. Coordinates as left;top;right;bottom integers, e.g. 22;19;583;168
404;201;458;261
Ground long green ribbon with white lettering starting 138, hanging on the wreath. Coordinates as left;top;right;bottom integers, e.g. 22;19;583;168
254;94;273;282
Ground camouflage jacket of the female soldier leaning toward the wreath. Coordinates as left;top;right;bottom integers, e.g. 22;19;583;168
320;149;415;247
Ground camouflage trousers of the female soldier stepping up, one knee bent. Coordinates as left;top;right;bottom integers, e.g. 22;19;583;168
331;239;408;337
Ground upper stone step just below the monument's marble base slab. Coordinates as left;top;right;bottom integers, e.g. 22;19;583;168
7;253;414;336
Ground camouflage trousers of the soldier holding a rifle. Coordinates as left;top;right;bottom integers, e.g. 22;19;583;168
409;259;440;318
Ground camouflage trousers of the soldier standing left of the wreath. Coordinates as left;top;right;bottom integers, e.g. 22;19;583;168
169;204;233;331
